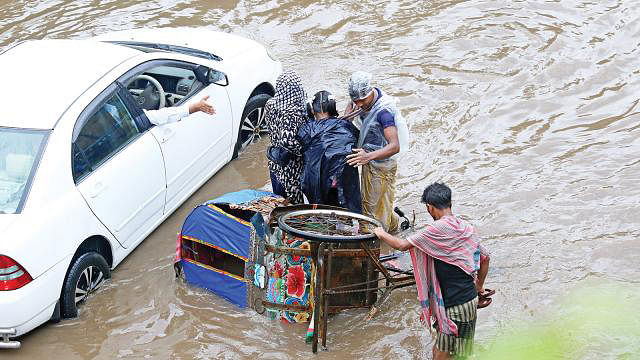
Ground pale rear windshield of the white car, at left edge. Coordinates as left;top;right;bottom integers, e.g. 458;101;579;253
0;127;48;214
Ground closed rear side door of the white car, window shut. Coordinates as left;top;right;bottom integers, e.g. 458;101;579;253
72;84;166;247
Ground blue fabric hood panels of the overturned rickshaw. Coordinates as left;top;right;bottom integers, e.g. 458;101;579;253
180;190;276;307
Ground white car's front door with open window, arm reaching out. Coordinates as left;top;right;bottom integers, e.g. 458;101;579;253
121;60;233;212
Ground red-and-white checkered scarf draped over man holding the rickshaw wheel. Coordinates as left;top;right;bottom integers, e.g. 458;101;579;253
407;215;489;336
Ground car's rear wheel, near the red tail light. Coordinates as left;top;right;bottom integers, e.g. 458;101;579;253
61;252;111;318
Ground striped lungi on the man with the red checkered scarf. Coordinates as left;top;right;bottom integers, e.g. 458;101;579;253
433;297;478;359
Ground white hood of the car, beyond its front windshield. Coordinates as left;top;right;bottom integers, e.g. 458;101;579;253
93;28;262;60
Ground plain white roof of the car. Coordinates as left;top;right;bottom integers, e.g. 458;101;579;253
0;40;142;129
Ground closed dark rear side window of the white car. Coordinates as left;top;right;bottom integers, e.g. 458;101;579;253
72;94;140;180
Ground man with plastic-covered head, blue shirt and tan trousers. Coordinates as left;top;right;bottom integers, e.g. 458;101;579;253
345;71;409;232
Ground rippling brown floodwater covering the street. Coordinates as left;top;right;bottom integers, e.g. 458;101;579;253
0;0;640;359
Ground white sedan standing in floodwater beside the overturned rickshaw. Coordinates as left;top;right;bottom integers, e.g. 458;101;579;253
0;29;282;348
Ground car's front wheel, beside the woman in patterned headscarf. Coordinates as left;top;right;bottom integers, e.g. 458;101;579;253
233;94;271;159
